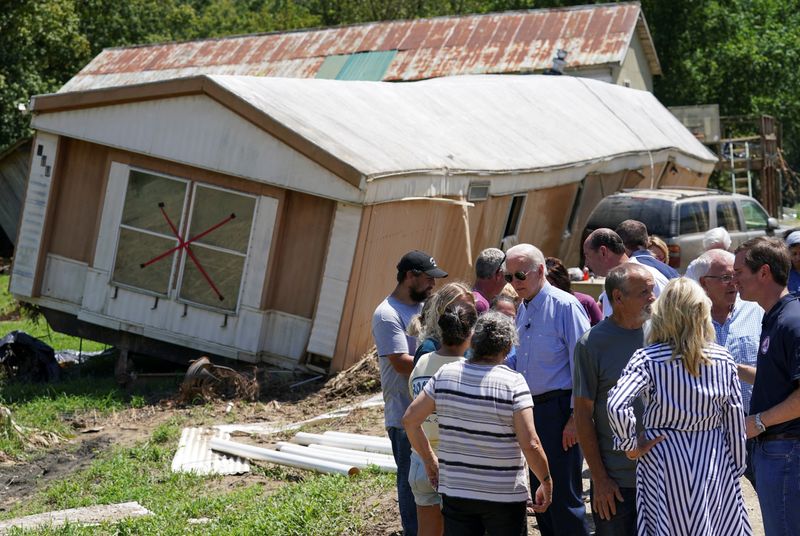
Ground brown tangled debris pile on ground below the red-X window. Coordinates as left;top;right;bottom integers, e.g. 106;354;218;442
178;356;260;404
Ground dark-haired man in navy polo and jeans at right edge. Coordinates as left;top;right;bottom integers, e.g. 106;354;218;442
733;237;800;536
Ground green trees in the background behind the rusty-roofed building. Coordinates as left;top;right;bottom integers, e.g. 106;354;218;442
0;0;800;176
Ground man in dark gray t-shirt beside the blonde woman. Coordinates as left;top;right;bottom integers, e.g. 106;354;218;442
573;263;655;536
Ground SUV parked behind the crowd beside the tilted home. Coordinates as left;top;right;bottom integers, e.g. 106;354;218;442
581;188;778;272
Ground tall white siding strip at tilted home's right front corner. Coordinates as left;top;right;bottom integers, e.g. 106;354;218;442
308;203;361;358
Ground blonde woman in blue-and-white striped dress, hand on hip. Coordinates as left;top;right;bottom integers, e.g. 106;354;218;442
608;278;752;536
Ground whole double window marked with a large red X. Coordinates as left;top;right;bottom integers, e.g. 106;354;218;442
112;170;256;312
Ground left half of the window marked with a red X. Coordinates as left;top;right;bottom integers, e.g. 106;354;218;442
112;170;189;296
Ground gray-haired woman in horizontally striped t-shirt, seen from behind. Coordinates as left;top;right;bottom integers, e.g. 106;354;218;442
403;311;553;535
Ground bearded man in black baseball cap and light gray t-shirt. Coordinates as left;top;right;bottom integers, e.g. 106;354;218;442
372;250;447;536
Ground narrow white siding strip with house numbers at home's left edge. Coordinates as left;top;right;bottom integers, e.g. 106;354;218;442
10;132;58;297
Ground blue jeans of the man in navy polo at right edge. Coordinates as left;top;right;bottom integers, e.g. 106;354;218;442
753;439;800;536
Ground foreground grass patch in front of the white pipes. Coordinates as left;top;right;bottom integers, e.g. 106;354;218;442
0;423;394;535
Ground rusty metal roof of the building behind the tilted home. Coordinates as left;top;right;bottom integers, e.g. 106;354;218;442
61;2;661;92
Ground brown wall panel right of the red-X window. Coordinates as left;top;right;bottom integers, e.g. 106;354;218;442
266;192;336;318
